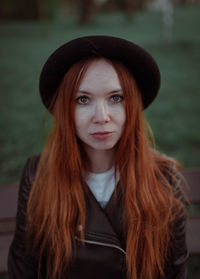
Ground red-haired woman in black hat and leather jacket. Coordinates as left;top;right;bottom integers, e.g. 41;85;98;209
8;36;188;279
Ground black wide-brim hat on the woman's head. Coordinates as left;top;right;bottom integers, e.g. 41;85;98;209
39;36;160;109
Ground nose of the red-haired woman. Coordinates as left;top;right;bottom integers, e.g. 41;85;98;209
93;102;110;124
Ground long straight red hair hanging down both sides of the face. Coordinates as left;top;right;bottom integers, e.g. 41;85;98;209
27;58;186;279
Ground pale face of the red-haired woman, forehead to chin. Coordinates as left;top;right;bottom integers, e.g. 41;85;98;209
75;59;126;154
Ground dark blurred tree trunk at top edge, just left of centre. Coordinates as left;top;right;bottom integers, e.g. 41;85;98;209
78;0;95;24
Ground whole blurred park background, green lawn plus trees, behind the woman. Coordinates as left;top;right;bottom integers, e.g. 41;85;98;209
0;0;200;279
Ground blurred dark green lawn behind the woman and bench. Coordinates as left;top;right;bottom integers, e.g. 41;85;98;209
0;5;200;185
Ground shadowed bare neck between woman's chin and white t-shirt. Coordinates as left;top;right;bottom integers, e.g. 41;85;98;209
85;147;115;173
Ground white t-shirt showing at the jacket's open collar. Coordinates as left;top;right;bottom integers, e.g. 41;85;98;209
86;167;119;208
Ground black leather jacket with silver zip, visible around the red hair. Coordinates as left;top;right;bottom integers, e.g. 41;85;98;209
8;156;188;279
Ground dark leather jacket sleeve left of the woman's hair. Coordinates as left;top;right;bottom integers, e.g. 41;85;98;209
7;155;45;279
